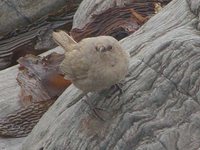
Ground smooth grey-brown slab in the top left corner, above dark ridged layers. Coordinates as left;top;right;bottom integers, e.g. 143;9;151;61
0;0;81;36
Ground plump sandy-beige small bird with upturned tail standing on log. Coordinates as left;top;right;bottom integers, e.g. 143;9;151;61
52;30;130;119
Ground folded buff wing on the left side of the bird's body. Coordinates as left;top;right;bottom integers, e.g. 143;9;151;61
60;50;89;80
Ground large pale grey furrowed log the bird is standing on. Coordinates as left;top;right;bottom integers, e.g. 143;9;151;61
19;0;200;150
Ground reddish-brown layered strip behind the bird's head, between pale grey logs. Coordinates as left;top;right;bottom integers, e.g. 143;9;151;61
70;0;169;41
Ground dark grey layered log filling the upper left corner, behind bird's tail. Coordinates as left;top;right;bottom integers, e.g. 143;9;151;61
0;0;81;70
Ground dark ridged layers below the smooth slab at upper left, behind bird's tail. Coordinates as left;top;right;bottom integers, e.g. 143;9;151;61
0;1;79;70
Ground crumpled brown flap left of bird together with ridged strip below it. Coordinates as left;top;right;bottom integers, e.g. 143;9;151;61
0;53;71;137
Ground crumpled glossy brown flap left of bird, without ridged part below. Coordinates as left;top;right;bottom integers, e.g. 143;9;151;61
17;53;70;105
